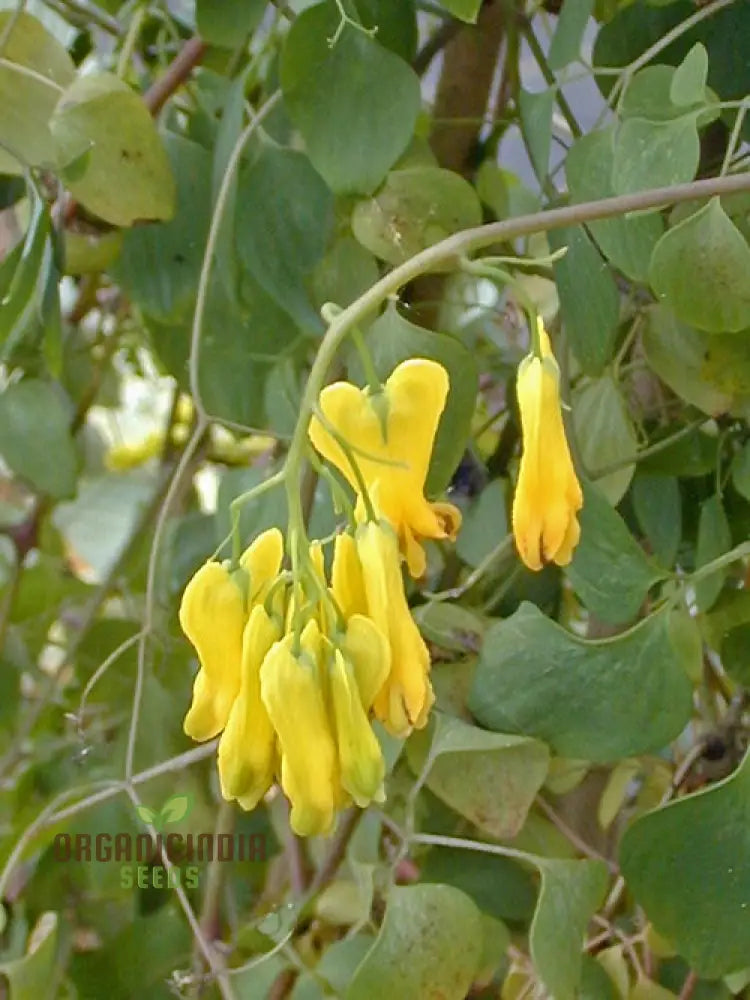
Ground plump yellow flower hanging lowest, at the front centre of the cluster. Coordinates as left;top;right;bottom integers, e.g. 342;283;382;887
260;619;340;837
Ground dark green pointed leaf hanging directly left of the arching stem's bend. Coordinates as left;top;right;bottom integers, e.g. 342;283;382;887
236;144;333;331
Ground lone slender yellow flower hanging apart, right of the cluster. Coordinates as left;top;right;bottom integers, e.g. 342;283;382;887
513;323;583;570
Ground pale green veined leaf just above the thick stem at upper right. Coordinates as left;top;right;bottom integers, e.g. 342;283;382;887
612;117;700;194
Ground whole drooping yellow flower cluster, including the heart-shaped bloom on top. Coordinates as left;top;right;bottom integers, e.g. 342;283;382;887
180;359;459;836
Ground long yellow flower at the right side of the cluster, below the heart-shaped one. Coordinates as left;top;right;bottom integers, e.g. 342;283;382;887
357;521;435;736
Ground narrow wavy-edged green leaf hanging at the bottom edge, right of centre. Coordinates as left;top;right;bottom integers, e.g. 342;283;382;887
530;858;609;1000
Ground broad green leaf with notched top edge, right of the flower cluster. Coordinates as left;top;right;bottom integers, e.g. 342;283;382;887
469;603;692;762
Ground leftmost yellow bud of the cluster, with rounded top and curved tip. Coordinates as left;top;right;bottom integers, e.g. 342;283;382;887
179;562;245;740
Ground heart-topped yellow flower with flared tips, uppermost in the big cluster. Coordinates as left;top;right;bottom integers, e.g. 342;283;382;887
309;358;461;577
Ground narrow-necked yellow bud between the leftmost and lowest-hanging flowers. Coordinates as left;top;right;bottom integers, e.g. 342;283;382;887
218;604;281;809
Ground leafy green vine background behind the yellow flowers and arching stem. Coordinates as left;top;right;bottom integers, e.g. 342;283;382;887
0;0;750;1000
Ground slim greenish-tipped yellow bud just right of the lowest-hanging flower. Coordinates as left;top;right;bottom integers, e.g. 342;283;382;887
330;649;385;809
